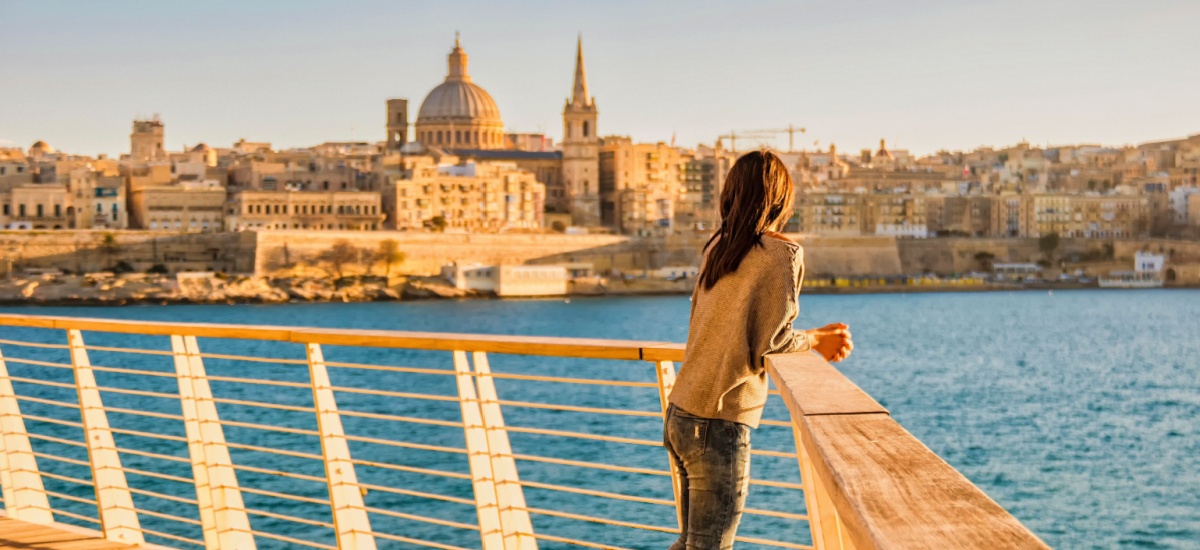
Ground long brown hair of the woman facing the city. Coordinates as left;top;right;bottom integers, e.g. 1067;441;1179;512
700;150;794;289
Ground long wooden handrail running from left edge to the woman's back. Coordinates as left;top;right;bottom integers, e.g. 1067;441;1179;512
0;313;683;361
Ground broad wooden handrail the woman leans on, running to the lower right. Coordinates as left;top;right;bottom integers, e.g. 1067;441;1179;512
767;353;1049;550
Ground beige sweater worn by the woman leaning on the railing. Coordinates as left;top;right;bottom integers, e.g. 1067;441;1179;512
670;235;812;428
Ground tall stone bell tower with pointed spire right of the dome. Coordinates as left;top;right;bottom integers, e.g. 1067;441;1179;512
563;36;600;226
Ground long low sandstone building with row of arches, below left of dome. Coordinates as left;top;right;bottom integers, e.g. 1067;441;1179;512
226;191;384;231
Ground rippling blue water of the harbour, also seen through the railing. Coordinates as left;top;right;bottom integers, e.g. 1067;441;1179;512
0;291;1200;549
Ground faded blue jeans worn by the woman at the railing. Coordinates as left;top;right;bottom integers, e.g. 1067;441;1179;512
662;405;750;550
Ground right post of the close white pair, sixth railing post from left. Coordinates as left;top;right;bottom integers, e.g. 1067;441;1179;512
472;352;538;550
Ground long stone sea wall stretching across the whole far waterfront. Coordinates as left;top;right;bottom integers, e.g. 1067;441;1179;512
0;231;1200;281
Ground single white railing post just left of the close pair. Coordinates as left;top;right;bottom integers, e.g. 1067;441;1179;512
305;343;376;550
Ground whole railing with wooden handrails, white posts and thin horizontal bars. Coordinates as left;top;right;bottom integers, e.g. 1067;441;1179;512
0;315;1045;550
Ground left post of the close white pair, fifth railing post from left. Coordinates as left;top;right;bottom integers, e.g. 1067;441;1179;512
454;352;504;550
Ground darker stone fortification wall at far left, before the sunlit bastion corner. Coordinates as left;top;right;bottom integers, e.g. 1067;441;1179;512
0;231;256;273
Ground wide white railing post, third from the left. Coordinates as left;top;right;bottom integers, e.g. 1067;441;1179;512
170;336;256;550
